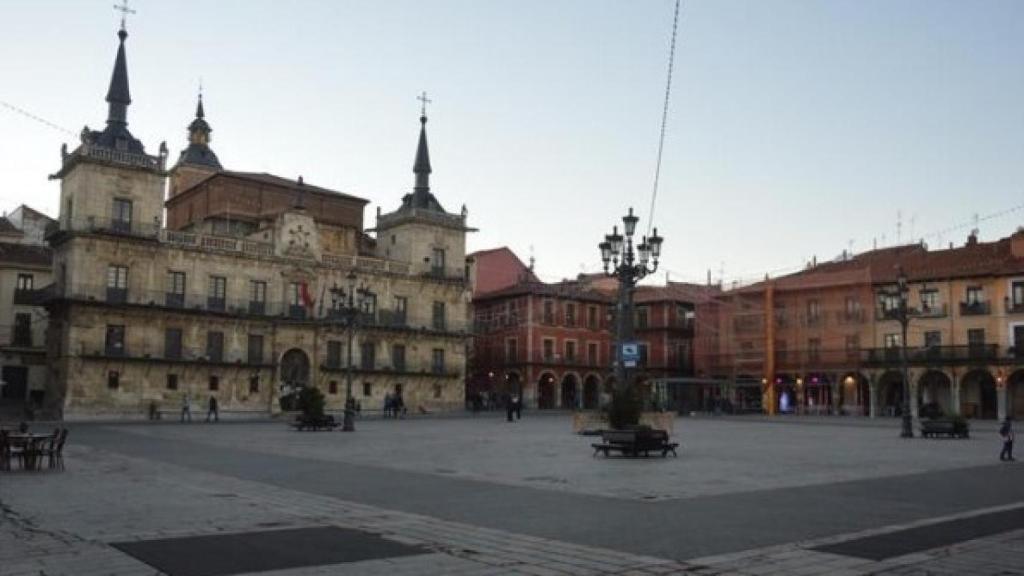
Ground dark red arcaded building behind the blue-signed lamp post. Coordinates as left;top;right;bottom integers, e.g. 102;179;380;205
467;248;699;409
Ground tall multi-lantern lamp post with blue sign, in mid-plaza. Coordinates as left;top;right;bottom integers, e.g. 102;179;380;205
597;208;665;399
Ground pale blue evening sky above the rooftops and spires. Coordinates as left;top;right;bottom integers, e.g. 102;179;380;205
0;0;1024;284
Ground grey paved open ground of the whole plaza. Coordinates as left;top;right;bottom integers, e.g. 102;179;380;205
0;413;1024;576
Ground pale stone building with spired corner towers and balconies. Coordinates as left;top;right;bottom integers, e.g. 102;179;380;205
38;23;470;418
